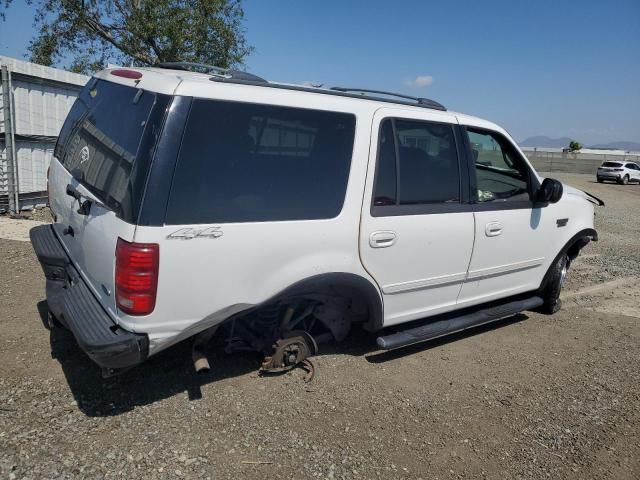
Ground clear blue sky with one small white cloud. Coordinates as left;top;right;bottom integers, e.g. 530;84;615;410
0;0;640;144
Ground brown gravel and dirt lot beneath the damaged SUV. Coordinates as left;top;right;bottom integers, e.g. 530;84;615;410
0;175;640;480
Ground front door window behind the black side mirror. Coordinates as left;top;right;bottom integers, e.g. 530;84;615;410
467;128;529;202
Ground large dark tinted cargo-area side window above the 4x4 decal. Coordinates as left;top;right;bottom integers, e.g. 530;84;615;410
166;99;355;225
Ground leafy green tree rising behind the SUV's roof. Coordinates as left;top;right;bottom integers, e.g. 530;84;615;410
0;0;252;73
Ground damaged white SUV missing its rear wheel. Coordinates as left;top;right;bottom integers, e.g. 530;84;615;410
31;64;602;374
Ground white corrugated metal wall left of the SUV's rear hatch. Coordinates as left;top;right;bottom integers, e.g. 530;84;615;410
0;56;89;211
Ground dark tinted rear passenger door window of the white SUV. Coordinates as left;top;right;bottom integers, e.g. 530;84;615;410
373;119;460;206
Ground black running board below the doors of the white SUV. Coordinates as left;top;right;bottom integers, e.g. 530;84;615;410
377;297;544;350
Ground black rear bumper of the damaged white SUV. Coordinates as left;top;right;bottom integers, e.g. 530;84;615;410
29;225;149;368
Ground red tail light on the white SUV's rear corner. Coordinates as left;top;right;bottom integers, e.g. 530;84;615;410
116;238;160;315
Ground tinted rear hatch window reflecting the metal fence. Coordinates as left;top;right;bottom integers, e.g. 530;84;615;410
55;80;168;223
